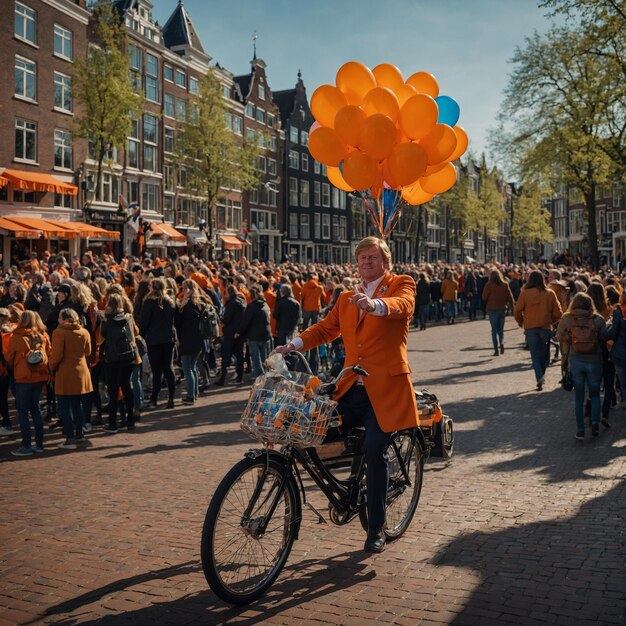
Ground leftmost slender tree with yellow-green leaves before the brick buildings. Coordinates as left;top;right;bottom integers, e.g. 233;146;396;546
72;2;143;206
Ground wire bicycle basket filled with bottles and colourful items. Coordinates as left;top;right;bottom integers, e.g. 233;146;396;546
241;374;338;448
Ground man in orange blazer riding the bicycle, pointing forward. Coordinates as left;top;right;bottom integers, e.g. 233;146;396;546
275;237;417;552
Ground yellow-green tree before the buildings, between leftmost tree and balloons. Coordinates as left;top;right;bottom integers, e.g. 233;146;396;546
176;69;260;258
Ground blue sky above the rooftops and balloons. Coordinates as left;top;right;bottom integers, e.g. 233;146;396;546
153;0;549;161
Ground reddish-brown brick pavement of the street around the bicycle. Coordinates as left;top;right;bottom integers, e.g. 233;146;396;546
0;318;626;626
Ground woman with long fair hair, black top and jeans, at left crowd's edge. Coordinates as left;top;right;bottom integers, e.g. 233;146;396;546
174;278;202;404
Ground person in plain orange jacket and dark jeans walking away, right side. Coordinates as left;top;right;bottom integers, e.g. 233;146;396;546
513;270;562;391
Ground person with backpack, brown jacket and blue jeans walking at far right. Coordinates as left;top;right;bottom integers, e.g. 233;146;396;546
557;293;606;440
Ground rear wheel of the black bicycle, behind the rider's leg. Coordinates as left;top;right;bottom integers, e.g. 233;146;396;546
359;431;424;541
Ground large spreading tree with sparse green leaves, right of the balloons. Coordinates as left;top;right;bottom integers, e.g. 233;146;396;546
492;28;614;266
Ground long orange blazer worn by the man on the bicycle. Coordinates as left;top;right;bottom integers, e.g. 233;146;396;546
300;272;417;433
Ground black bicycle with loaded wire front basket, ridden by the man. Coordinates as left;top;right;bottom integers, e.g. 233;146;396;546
201;352;452;604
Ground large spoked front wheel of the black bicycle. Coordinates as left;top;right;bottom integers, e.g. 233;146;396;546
201;457;299;604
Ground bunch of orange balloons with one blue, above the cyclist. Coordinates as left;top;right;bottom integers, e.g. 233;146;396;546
309;61;468;238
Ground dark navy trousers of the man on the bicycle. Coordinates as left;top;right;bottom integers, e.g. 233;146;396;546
337;384;391;529
